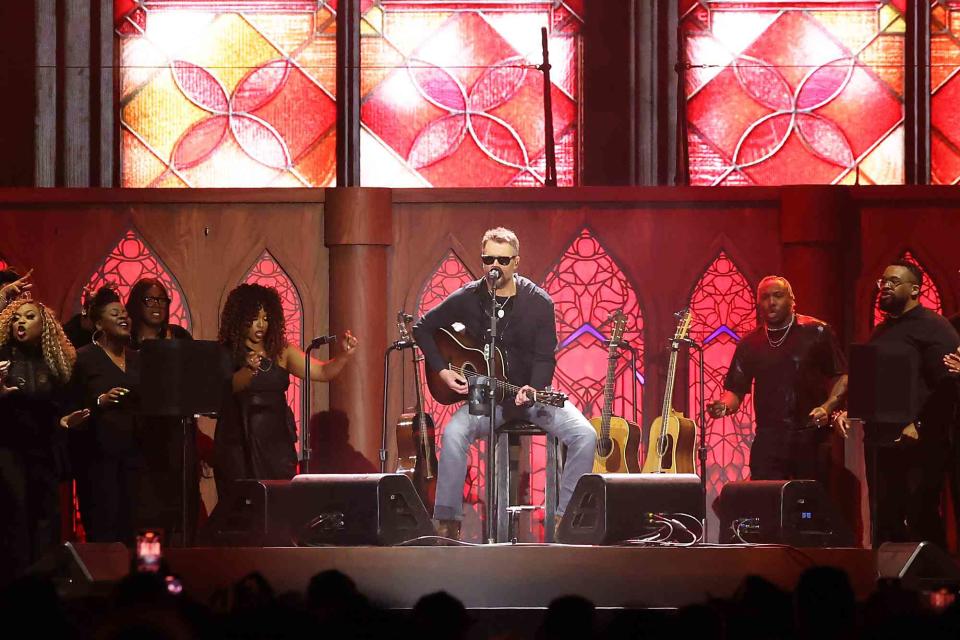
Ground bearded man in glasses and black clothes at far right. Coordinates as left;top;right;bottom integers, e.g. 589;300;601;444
867;261;960;545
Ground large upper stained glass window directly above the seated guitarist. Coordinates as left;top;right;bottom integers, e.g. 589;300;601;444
361;0;582;187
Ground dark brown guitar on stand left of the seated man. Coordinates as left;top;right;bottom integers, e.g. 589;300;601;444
397;311;437;513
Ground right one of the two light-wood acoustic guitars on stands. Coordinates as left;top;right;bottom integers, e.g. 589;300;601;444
642;309;697;473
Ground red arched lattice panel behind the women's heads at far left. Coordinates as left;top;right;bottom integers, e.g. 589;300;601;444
85;229;193;331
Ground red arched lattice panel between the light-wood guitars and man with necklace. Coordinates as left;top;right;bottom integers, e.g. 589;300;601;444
687;252;757;541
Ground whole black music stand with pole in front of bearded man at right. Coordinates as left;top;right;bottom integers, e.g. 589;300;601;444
847;343;920;548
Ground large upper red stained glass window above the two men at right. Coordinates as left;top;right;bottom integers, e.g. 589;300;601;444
679;0;906;185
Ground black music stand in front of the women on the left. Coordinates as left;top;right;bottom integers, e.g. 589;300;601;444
139;340;230;547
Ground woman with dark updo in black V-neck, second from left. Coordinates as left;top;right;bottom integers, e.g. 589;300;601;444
70;287;143;543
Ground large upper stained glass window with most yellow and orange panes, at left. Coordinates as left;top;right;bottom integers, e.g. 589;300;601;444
115;0;336;187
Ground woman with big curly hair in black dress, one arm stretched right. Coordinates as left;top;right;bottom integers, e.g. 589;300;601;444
214;284;358;497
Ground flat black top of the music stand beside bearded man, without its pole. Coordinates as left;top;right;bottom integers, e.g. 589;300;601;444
847;343;918;425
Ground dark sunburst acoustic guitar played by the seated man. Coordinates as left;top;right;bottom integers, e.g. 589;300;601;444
427;327;567;407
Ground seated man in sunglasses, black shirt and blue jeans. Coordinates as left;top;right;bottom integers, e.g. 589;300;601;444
413;228;596;538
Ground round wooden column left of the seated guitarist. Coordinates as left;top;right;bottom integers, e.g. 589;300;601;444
324;187;393;468
